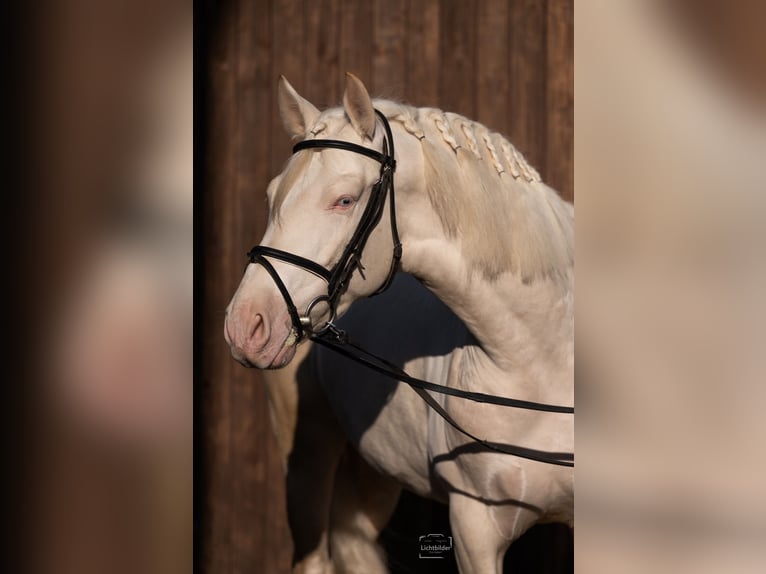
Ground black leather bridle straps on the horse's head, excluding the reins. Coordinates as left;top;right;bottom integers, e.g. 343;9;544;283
247;110;402;341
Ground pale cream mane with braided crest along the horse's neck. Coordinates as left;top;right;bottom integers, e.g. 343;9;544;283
374;100;574;282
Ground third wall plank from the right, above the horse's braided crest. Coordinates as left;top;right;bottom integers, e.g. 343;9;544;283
474;0;510;135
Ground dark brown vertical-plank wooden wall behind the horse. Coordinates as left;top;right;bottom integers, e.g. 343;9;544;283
201;0;573;574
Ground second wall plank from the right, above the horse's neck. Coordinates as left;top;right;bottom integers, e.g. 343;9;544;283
508;0;547;180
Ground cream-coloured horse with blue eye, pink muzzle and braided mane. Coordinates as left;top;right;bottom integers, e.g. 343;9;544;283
225;76;574;573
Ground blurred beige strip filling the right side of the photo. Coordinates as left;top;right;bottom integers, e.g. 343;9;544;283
575;0;766;574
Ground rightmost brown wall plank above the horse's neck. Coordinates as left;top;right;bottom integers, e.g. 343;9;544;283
546;0;574;201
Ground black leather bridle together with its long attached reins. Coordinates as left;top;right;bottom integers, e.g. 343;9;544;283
247;110;574;467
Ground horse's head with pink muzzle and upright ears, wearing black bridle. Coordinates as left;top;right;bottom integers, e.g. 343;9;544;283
224;74;398;368
